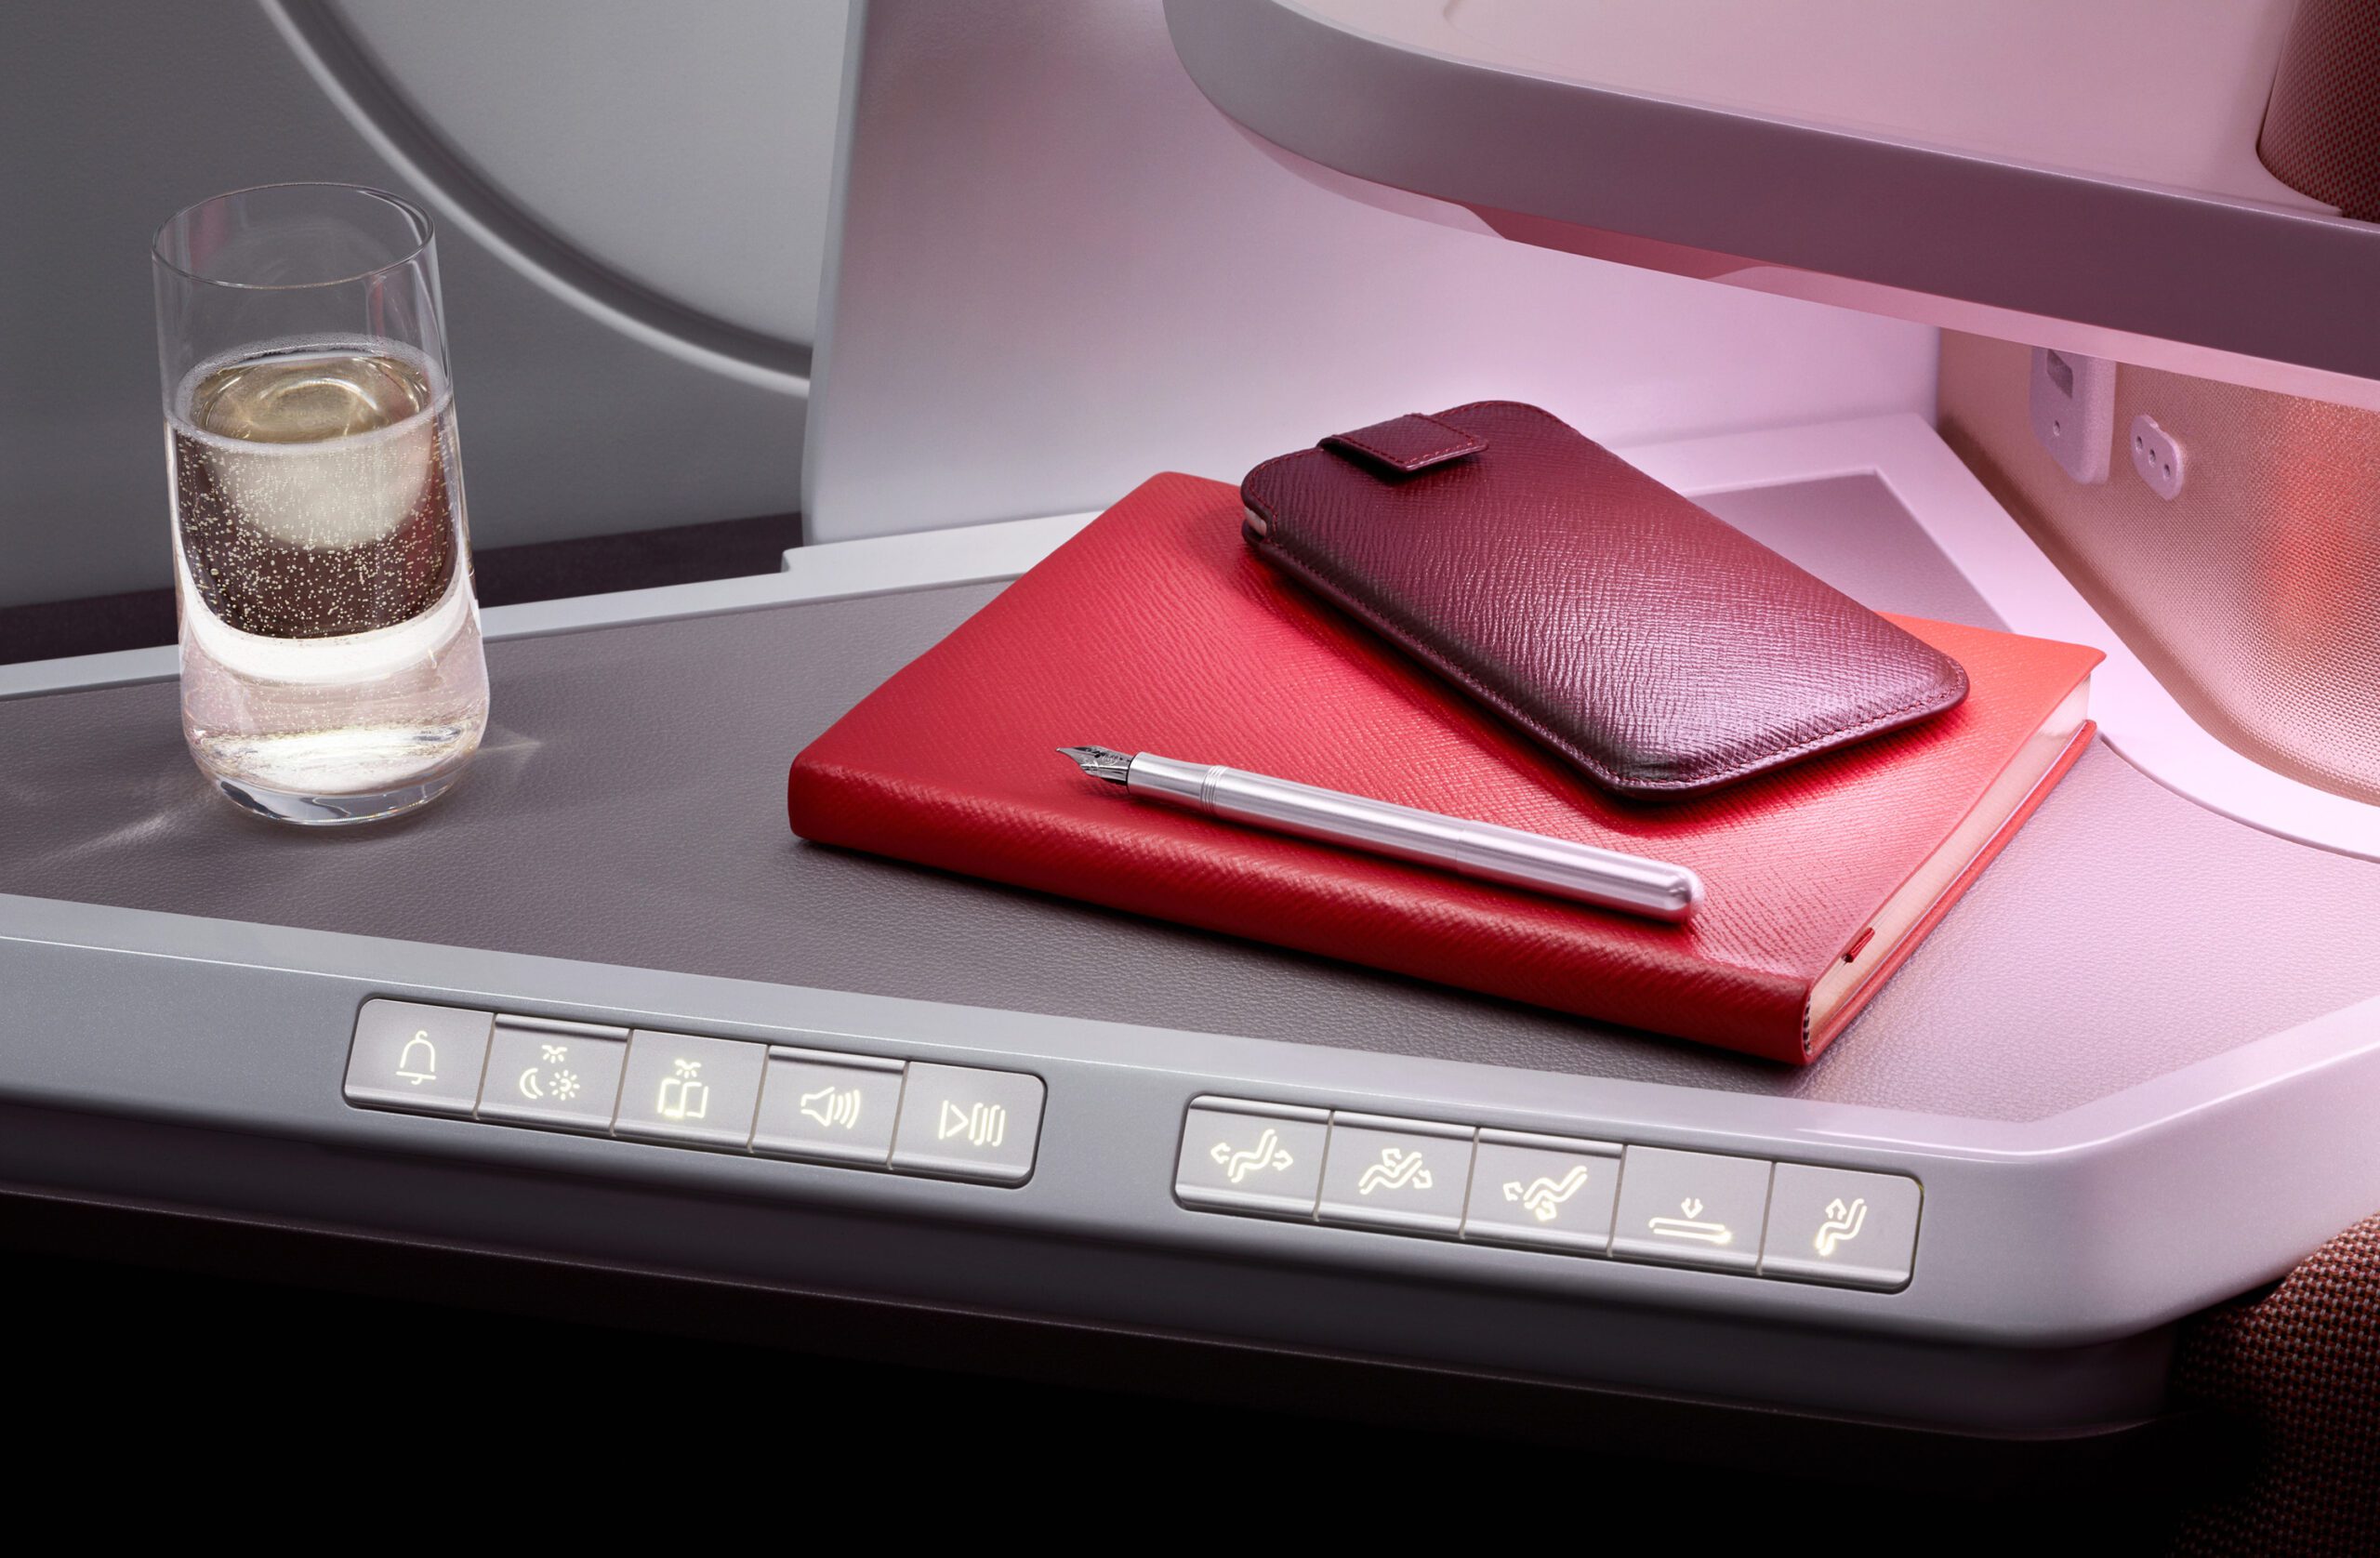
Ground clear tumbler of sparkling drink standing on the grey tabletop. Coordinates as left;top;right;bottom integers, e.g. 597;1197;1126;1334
154;183;488;823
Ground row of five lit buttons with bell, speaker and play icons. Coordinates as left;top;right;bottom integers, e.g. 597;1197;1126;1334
345;999;1045;1184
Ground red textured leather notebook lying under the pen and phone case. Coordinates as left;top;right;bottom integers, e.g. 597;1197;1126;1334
787;476;2099;1063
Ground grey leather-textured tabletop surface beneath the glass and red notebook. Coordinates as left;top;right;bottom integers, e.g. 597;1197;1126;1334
0;478;2380;1120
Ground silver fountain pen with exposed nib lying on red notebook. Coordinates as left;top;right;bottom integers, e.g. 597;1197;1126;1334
1059;746;1701;925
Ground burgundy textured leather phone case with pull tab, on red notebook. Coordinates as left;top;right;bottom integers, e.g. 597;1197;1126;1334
1240;400;1966;797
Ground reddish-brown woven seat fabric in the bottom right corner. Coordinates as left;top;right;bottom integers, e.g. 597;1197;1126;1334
2175;1216;2380;1558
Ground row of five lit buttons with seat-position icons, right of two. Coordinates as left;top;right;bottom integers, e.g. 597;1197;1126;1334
1173;1099;1923;1291
